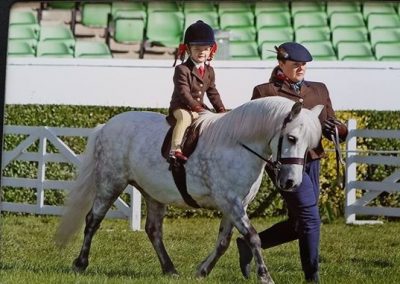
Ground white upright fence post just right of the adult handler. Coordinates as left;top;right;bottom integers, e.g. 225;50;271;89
344;119;357;224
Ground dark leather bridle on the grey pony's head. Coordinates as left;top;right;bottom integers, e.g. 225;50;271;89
240;103;308;185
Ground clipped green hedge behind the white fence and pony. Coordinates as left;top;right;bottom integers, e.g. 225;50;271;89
2;105;400;222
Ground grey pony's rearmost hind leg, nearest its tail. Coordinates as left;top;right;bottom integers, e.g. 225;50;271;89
72;183;126;272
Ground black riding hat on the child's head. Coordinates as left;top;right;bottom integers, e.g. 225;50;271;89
183;20;215;45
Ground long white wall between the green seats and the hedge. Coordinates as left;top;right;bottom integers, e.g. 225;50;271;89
5;58;400;110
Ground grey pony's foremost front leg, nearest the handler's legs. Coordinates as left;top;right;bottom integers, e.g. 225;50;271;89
228;200;274;284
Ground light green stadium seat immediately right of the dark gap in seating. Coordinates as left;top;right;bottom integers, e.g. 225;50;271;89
113;10;146;44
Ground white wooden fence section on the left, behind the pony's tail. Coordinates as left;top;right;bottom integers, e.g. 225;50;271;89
0;126;141;230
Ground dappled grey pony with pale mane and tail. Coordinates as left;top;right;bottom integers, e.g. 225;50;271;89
56;97;322;283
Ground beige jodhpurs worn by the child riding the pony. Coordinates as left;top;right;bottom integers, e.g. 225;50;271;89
171;108;199;151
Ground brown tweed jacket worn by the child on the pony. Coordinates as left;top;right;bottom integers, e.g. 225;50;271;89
169;58;225;116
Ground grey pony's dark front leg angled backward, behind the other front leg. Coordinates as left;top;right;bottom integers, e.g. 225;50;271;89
196;216;233;277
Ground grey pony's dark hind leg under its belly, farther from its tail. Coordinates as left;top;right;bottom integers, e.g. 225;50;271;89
145;197;178;275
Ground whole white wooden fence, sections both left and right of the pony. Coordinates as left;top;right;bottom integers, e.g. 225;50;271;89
0;120;400;226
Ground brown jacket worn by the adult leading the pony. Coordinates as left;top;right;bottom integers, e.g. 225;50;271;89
251;65;335;161
